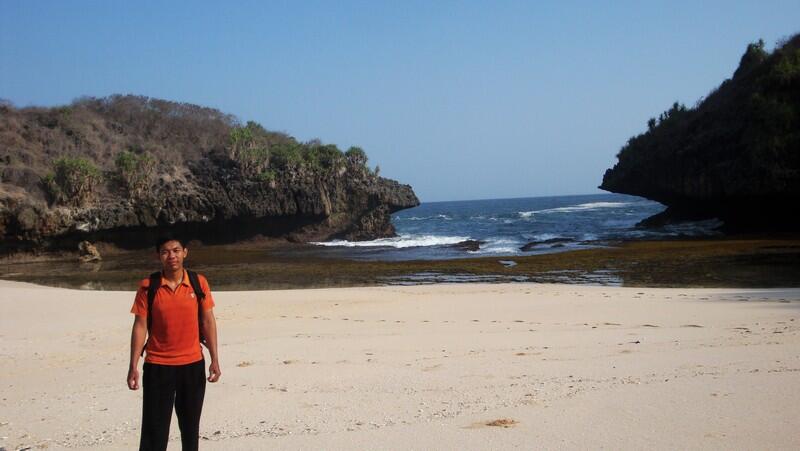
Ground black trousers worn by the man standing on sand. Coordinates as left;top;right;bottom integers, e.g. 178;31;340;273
139;360;206;451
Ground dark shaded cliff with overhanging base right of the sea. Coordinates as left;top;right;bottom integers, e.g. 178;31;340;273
600;35;800;230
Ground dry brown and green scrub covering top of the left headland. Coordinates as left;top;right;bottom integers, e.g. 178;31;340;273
0;95;370;206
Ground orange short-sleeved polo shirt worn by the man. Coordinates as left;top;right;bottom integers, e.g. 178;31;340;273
131;270;214;365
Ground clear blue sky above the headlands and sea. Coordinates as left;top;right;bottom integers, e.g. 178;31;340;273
0;0;800;201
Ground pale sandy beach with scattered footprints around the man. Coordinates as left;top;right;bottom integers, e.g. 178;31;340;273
0;280;800;450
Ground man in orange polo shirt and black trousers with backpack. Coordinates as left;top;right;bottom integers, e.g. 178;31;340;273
128;235;222;451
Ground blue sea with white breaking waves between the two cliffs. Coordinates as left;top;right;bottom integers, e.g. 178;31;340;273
312;194;721;260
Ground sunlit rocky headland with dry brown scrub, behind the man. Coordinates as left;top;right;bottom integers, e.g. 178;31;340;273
0;96;419;254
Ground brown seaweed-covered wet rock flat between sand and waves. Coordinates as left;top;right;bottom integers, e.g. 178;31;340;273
0;235;800;291
